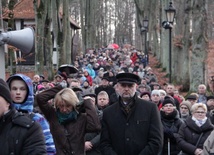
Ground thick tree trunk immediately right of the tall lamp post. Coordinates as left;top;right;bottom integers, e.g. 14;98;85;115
172;0;191;90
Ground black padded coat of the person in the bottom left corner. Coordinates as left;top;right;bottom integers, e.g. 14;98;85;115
0;109;46;155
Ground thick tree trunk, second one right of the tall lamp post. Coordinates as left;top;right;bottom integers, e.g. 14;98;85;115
190;0;207;91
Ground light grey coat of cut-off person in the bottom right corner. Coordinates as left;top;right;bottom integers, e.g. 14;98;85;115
203;130;214;155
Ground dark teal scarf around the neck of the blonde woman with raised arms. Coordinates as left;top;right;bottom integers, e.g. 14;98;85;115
56;110;78;125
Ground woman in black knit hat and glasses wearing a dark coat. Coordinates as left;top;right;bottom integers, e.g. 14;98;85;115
160;96;182;155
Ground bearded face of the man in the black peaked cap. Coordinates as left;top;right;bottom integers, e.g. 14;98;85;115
117;83;137;100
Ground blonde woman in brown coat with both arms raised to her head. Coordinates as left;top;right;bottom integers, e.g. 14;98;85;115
36;86;100;155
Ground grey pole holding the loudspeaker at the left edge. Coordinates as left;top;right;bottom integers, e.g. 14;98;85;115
0;0;5;80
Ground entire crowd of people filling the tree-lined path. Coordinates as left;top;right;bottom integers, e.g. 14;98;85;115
0;48;214;155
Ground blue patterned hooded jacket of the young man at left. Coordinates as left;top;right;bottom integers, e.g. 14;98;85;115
7;74;56;154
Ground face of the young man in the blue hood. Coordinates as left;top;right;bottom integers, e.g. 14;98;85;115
10;80;27;103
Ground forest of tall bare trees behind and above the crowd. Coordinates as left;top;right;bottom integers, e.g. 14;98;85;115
2;0;214;91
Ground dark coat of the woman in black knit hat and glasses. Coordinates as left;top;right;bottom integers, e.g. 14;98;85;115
160;109;183;155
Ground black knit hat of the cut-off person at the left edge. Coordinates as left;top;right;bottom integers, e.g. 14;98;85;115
0;79;12;104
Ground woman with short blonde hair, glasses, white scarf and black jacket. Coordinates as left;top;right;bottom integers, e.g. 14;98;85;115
176;103;213;155
